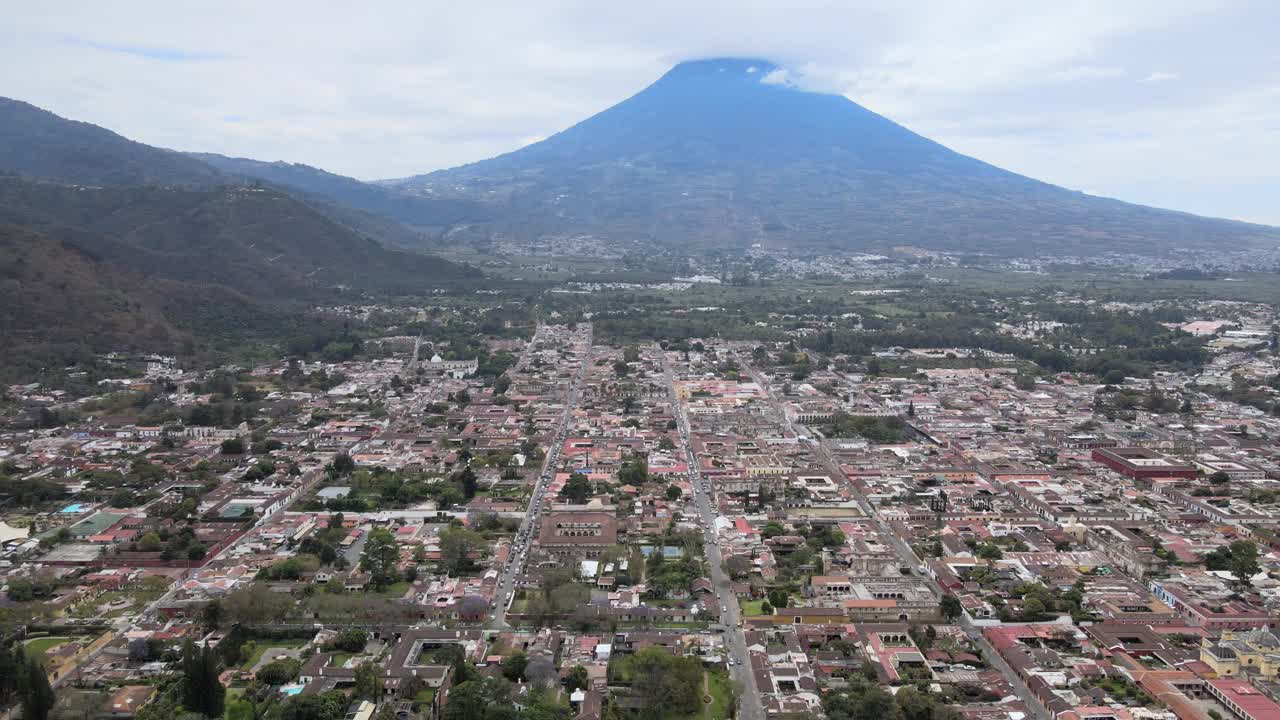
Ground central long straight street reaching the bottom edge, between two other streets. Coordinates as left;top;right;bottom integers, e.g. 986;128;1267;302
659;350;764;720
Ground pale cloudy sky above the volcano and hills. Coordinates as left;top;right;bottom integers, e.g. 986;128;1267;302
0;0;1280;225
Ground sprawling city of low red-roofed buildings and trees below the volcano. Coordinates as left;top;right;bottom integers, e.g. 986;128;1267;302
0;283;1280;720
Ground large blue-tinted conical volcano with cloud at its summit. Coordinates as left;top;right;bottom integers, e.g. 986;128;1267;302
387;59;1280;255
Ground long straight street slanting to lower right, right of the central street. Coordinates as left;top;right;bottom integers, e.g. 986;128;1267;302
733;350;1050;720
